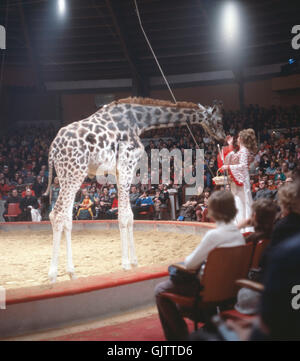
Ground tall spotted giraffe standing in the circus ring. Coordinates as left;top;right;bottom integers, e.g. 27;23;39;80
45;98;225;283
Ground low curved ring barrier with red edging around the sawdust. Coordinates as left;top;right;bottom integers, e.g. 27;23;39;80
0;220;214;339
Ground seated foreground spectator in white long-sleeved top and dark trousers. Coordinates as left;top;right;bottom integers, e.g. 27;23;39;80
155;191;245;341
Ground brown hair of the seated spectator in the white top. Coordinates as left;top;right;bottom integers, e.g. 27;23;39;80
207;191;237;223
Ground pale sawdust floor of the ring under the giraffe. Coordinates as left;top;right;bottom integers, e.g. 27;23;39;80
0;230;201;289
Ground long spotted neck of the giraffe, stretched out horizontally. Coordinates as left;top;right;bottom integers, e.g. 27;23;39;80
130;104;204;135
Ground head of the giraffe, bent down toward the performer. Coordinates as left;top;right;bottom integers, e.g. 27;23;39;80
198;101;226;142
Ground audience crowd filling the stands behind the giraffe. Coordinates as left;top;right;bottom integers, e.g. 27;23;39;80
0;105;300;222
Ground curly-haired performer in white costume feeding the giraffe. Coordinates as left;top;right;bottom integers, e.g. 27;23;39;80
222;129;257;226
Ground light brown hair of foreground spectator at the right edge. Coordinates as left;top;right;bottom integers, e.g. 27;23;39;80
278;181;300;214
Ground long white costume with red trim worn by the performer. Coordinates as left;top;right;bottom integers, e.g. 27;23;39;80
225;146;253;226
